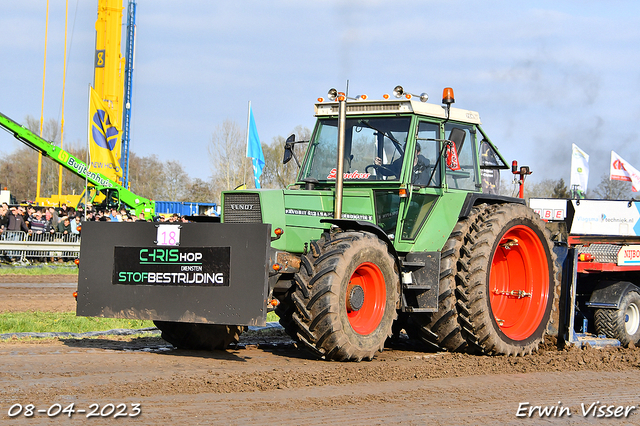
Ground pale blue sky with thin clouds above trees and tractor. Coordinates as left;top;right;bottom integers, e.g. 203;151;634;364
0;0;640;191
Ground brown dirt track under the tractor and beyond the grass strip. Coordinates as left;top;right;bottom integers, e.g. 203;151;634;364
0;283;640;425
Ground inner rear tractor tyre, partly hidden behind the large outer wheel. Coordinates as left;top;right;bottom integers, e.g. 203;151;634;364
405;208;482;352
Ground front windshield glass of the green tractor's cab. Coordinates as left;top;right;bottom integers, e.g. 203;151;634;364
302;117;411;181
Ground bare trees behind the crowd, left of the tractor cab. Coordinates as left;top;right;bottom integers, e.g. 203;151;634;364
0;116;311;203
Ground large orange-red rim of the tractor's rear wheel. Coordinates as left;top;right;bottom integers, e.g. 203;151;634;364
489;225;549;340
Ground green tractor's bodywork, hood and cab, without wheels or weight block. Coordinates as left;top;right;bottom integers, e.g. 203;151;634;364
222;100;508;253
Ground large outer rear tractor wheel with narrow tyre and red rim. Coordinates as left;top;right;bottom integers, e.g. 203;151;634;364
458;204;560;356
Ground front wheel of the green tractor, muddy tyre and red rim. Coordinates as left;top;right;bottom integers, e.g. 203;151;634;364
287;232;400;361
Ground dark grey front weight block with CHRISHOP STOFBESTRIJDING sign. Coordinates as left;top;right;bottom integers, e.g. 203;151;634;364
76;222;271;325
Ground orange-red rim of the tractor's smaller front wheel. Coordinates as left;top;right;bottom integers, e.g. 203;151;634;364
346;262;387;335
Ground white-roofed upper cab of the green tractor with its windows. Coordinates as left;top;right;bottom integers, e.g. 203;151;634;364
298;91;508;193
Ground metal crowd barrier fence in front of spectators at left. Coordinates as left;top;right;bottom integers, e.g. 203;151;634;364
0;231;80;263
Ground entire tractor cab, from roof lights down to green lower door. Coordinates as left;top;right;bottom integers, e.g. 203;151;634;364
288;86;509;248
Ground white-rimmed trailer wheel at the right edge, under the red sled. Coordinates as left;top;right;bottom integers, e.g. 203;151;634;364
594;291;640;346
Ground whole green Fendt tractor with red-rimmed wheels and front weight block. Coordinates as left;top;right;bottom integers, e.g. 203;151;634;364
78;86;560;361
